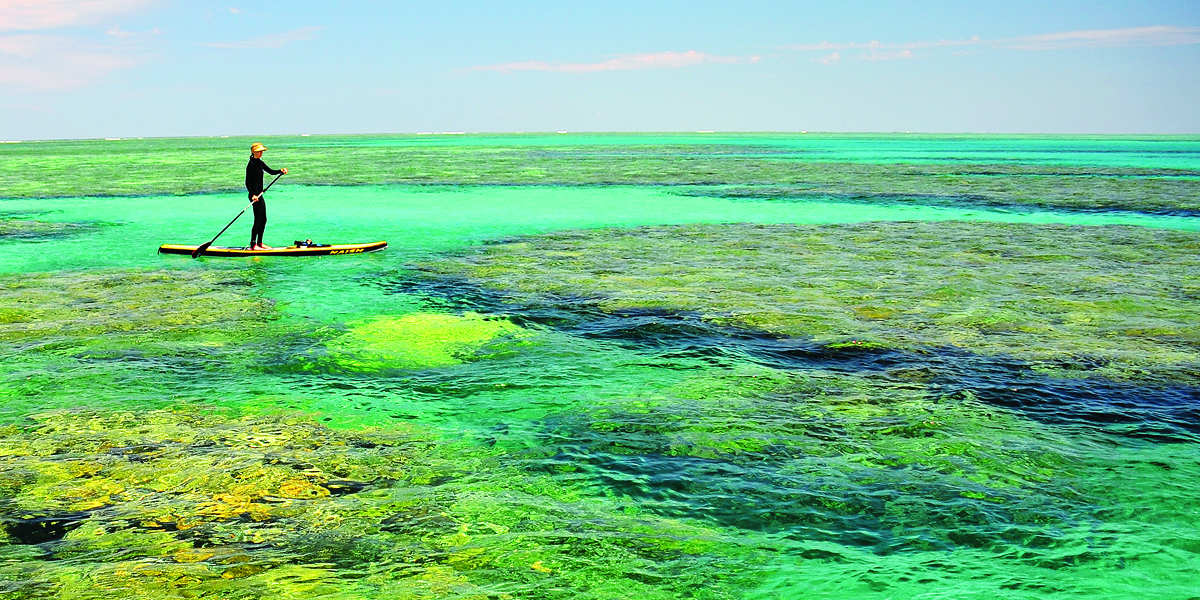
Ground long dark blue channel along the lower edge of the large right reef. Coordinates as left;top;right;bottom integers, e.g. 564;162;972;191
386;274;1200;443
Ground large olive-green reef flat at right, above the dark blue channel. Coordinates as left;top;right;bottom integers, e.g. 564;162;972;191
420;222;1200;382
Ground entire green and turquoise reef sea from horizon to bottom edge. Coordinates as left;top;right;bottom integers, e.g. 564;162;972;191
0;134;1200;599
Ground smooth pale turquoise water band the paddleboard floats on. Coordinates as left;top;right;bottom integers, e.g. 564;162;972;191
0;186;1200;272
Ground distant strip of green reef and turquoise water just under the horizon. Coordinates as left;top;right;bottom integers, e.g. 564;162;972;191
0;133;1200;216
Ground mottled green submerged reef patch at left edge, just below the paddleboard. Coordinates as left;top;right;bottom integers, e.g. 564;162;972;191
0;268;309;418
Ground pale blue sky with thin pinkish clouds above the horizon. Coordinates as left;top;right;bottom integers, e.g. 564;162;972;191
0;0;1200;140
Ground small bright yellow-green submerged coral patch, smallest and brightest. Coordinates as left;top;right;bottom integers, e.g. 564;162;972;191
326;313;523;371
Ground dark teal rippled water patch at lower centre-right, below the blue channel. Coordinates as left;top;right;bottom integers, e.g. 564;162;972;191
526;414;1099;557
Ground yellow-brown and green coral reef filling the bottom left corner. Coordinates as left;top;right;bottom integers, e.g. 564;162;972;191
0;407;752;599
